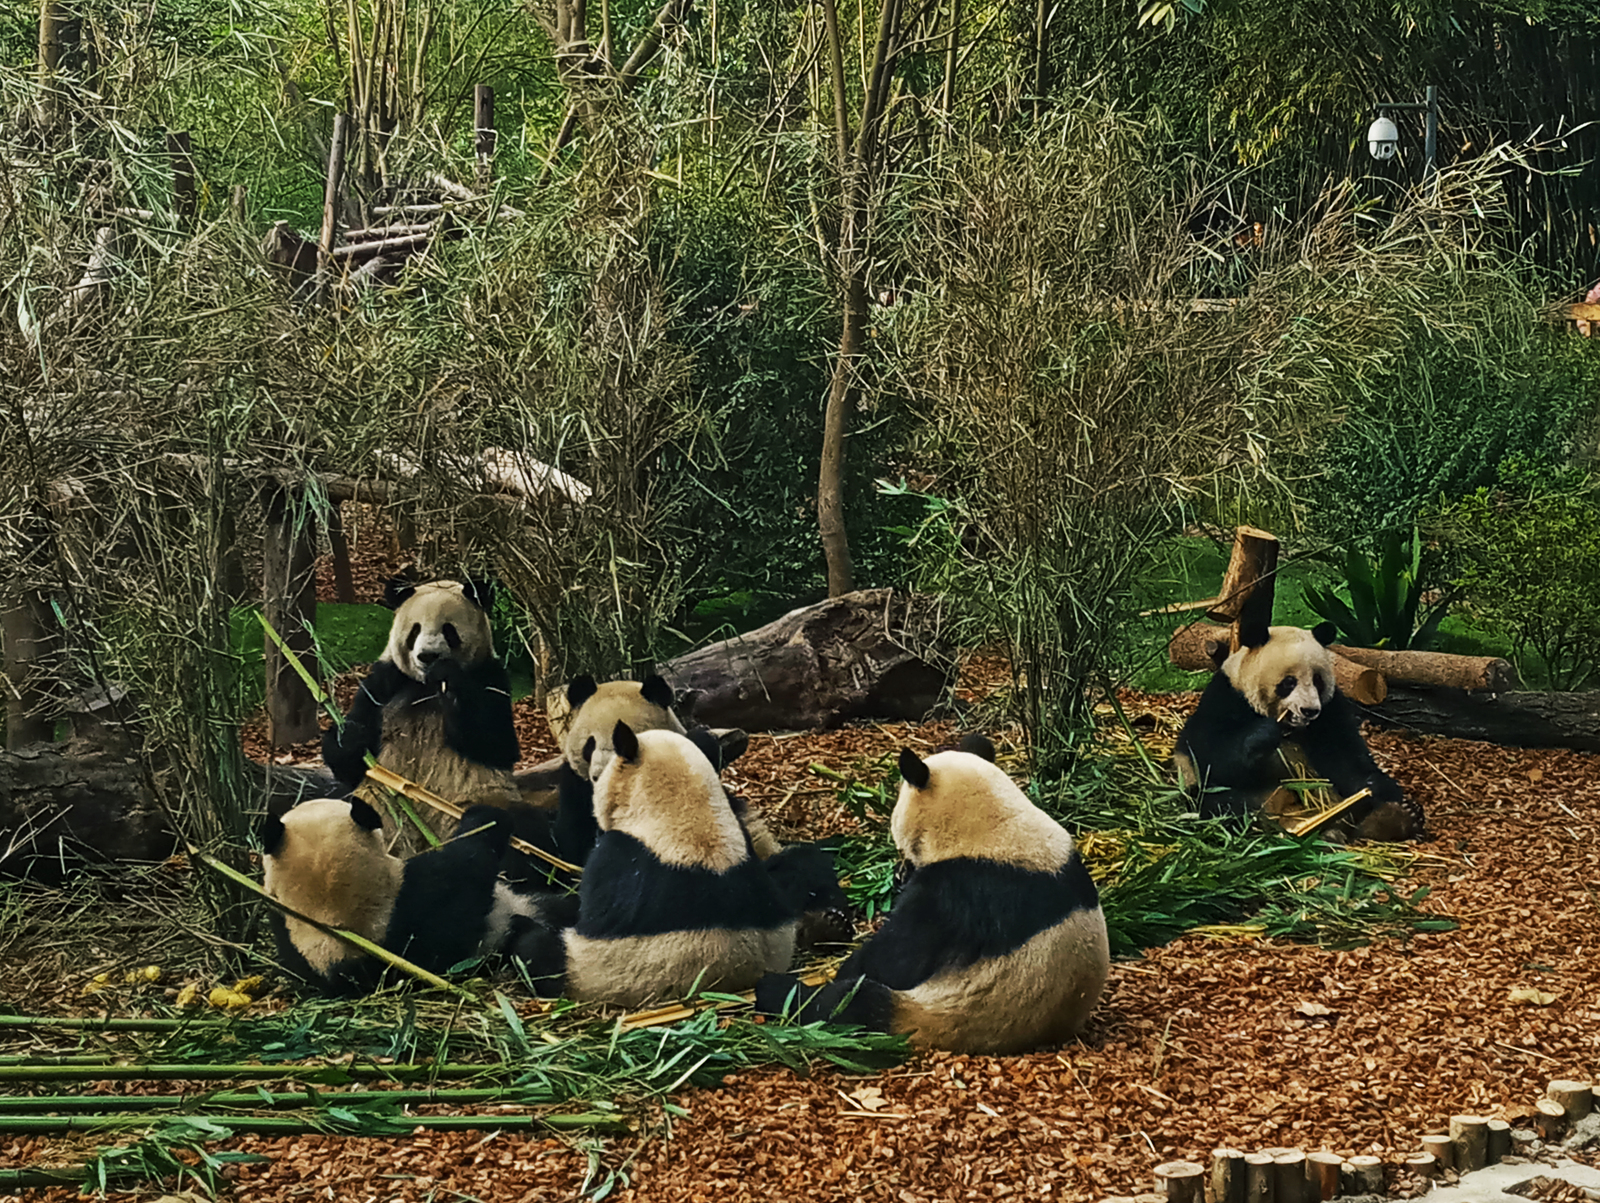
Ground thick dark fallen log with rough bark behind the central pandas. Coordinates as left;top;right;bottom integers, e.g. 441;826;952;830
662;589;955;731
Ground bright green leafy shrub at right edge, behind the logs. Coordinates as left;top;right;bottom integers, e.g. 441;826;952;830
1435;461;1600;689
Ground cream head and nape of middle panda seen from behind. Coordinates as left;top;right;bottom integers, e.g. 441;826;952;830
594;729;750;872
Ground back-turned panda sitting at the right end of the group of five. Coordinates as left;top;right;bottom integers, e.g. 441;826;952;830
755;737;1110;1053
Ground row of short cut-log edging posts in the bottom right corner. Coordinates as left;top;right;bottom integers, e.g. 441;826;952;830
1102;1081;1595;1203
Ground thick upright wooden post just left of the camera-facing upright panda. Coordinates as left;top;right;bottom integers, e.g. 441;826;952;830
261;488;320;747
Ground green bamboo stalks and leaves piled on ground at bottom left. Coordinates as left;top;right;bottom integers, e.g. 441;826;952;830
0;990;906;1193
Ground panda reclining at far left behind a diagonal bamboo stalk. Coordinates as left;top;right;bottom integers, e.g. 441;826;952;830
259;797;538;995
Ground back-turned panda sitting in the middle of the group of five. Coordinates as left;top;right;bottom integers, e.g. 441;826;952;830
512;721;795;1006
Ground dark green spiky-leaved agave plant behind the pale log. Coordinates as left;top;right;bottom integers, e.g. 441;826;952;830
1301;526;1456;651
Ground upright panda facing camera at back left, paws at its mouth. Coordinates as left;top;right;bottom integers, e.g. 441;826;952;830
322;581;520;851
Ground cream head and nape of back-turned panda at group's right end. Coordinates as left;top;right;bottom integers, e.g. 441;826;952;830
890;752;1074;873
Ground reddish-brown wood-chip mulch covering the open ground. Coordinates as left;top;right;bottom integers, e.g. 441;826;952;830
12;697;1600;1203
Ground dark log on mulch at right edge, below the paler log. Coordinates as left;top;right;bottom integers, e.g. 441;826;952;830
1360;685;1600;752
